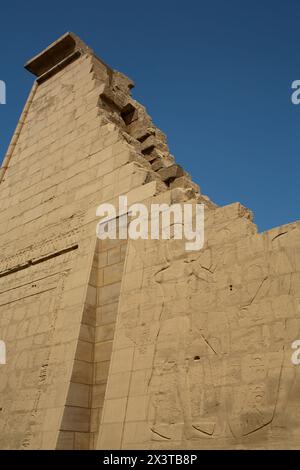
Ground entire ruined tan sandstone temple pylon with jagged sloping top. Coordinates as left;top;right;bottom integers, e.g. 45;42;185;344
0;33;300;449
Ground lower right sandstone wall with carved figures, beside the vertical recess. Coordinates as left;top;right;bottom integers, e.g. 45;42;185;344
98;197;300;449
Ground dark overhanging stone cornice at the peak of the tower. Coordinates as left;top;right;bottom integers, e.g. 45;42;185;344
24;32;93;78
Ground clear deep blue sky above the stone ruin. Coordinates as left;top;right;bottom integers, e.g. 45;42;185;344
0;0;300;230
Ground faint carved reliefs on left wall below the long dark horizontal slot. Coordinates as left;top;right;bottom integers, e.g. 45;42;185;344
0;268;69;448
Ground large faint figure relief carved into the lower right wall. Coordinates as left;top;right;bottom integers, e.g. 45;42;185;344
121;235;296;448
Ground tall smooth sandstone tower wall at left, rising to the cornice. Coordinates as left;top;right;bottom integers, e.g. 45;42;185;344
0;31;159;449
